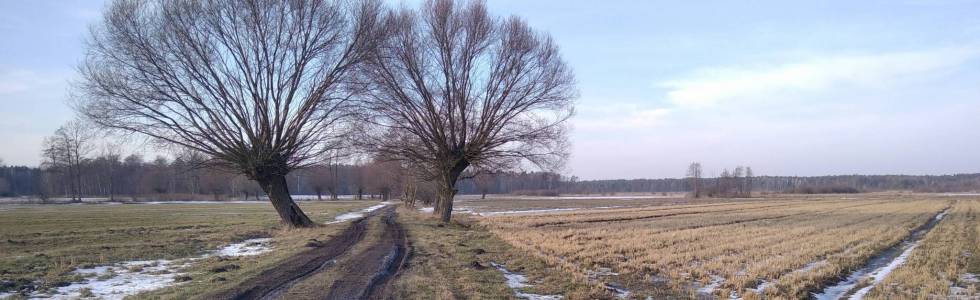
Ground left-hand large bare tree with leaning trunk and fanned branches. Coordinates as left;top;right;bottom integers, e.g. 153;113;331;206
76;0;385;227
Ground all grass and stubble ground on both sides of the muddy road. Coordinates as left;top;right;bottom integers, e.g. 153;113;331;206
0;194;980;299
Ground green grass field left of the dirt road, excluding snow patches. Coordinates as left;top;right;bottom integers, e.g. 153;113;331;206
0;201;374;298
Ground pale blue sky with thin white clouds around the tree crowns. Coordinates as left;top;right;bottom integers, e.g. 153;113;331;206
0;0;980;179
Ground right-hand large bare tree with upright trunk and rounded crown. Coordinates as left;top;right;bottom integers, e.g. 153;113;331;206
363;0;576;222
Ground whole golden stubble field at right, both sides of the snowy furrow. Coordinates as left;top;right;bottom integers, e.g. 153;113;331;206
485;195;980;299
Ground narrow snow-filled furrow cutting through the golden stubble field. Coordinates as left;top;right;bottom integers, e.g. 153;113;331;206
813;208;949;300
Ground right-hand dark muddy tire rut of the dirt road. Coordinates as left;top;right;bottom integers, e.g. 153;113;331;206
326;207;408;299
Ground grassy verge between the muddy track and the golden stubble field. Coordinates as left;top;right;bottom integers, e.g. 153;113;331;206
392;209;609;299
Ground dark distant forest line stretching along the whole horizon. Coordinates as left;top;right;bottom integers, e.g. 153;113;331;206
0;155;980;201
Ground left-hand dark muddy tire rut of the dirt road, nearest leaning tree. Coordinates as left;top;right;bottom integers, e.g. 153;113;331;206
205;209;373;300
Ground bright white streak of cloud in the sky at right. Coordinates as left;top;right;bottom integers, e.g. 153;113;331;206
659;48;980;108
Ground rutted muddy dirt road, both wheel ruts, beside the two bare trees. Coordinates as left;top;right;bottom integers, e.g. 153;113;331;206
205;206;408;300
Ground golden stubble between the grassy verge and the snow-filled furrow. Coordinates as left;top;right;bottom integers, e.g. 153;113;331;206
486;198;949;298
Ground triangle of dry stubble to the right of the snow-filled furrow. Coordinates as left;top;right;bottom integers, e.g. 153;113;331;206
868;199;980;299
